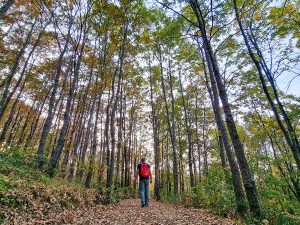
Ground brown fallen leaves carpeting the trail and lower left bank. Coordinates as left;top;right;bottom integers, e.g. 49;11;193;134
0;185;236;225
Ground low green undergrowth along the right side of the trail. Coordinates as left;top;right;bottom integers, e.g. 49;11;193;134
161;174;300;225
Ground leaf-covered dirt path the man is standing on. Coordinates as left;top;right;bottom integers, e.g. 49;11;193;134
50;199;235;225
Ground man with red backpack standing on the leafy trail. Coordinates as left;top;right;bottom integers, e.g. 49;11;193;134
136;158;152;207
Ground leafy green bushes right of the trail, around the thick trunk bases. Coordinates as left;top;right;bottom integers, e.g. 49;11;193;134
161;159;300;225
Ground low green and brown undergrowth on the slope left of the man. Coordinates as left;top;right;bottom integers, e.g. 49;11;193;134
0;146;136;219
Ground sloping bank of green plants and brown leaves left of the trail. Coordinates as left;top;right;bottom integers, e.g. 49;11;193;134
0;147;107;224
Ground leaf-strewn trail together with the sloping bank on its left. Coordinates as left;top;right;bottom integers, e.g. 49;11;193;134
0;150;235;225
